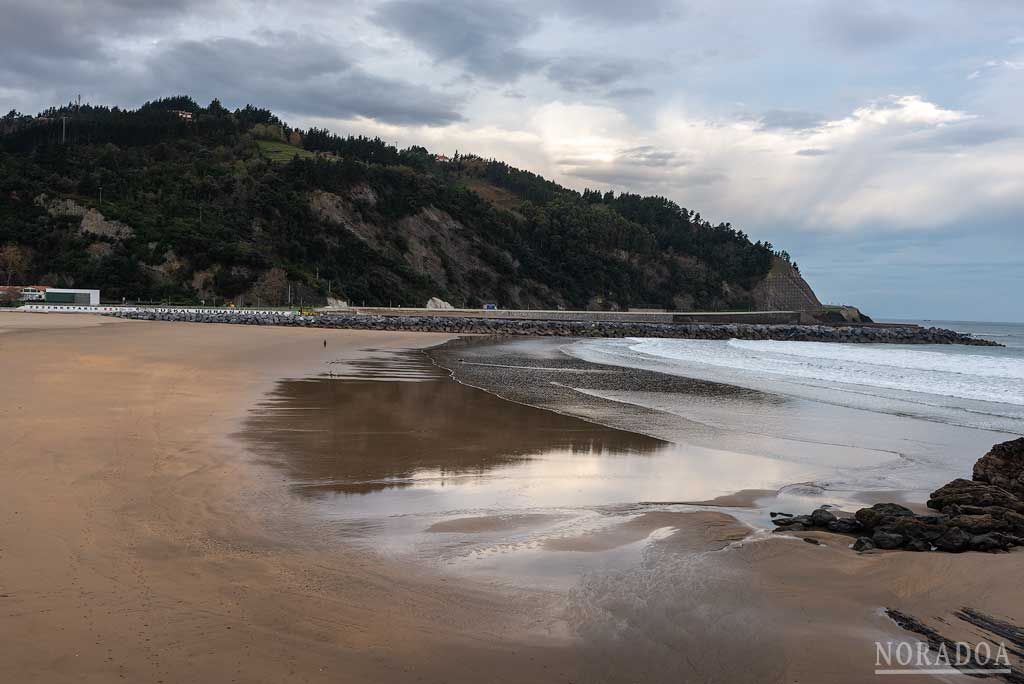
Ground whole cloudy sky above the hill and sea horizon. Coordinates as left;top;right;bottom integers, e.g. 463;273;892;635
0;0;1024;320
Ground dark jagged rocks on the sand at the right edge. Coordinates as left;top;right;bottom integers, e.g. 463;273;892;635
772;437;1024;553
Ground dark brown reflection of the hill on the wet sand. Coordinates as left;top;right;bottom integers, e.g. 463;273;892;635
245;354;667;494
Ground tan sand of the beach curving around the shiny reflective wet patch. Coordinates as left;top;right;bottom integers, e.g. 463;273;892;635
6;313;1024;683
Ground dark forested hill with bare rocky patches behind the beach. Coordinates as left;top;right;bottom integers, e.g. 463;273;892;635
0;97;815;309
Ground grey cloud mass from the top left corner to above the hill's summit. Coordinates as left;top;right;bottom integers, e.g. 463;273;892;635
0;0;462;125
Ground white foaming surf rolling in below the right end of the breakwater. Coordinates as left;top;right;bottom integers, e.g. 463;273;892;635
569;320;1024;434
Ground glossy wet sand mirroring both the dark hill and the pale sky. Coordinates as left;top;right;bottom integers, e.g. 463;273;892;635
244;353;847;589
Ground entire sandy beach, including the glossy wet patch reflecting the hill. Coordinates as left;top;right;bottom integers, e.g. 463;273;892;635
0;313;1024;683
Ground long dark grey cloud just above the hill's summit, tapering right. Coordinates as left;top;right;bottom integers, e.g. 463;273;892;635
148;34;462;125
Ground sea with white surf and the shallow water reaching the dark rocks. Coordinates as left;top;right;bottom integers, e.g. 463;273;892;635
562;320;1024;503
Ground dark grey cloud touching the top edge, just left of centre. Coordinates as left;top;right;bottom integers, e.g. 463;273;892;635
373;0;544;83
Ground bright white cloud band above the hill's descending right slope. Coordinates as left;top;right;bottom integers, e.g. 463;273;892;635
301;95;1024;237
